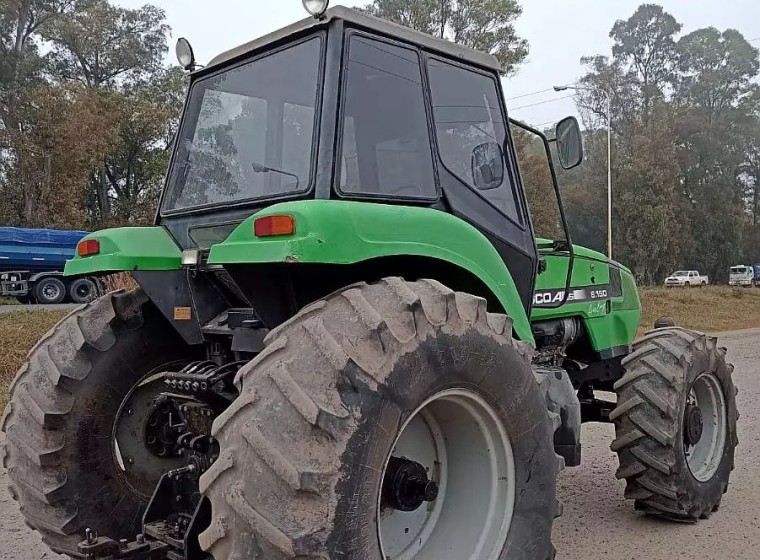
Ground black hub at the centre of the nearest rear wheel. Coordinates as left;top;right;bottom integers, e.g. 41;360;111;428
382;457;438;511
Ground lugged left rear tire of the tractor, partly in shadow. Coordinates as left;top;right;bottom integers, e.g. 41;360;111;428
2;291;196;555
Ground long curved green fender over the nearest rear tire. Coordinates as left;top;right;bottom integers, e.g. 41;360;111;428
208;200;534;343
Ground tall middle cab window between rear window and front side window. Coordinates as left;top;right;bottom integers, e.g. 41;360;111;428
339;34;437;199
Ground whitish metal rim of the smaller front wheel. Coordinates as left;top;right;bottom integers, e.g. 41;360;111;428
684;373;727;482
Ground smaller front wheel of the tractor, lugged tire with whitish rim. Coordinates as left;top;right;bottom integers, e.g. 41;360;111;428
610;328;739;522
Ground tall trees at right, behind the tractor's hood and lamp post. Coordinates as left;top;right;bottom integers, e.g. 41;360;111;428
563;4;760;283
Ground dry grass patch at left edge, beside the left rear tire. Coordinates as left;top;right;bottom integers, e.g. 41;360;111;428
0;311;68;411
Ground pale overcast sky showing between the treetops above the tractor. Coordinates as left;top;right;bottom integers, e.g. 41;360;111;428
115;0;760;125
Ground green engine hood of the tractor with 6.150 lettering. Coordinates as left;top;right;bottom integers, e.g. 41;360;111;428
531;240;641;351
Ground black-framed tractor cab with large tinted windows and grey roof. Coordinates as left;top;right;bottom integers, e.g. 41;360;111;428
157;7;582;316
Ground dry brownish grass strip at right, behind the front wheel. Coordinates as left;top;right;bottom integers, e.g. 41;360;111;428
641;286;760;332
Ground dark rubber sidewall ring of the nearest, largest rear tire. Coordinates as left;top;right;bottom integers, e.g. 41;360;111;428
328;331;557;560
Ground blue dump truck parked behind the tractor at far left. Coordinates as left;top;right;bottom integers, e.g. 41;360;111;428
0;227;97;304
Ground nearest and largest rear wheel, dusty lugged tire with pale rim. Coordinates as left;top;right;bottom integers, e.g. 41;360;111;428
200;278;562;560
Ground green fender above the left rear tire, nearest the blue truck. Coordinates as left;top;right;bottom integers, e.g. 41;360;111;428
65;227;182;276
